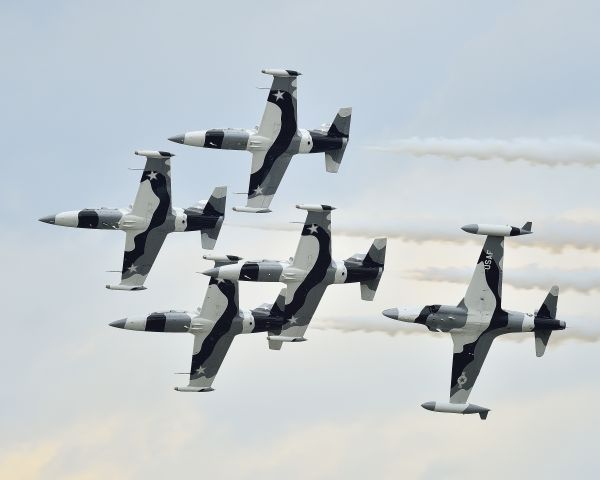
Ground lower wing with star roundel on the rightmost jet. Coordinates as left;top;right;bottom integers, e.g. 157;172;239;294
450;331;497;403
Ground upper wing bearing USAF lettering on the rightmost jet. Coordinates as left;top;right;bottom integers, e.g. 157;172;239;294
461;235;504;315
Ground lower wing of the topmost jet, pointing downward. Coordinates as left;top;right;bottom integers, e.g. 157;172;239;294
246;151;292;208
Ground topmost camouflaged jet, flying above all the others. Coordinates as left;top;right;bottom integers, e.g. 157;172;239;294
169;69;352;213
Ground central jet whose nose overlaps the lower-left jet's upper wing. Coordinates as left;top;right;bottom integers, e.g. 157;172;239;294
202;205;386;350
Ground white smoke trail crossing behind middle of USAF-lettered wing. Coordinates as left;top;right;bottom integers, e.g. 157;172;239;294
403;265;600;293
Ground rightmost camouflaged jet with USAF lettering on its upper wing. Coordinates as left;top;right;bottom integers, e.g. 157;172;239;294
383;222;565;420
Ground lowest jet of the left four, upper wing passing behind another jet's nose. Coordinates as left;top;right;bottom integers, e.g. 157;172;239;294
110;255;288;392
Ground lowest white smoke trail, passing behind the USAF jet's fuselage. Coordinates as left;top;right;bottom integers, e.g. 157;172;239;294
311;314;600;345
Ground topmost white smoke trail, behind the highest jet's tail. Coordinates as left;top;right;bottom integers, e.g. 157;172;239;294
372;137;600;166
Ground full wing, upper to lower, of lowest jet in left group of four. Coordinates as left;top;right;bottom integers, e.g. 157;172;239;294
177;278;242;392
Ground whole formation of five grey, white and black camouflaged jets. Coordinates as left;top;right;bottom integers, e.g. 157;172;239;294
39;65;566;419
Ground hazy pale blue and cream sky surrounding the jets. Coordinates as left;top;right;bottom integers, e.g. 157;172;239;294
0;0;600;480
